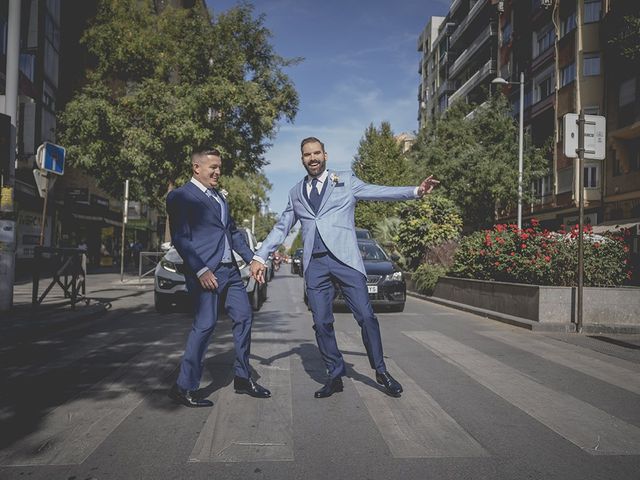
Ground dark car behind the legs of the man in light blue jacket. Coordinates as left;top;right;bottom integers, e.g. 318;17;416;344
304;239;407;312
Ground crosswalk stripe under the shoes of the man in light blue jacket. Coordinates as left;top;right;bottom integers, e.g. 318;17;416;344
336;332;488;458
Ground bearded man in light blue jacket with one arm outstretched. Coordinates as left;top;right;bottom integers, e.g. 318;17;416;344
251;137;439;398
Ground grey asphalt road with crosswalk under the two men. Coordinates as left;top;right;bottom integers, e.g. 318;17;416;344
0;272;640;480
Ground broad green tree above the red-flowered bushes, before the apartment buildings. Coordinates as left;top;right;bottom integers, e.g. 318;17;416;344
409;95;547;229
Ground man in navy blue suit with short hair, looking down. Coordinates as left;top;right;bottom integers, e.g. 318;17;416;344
167;150;271;407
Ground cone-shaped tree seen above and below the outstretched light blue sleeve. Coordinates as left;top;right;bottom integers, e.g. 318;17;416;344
352;122;411;230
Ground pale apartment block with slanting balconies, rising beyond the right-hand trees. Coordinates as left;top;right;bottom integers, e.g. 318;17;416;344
418;0;498;127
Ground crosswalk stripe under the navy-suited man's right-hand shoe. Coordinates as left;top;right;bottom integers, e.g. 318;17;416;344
189;333;294;462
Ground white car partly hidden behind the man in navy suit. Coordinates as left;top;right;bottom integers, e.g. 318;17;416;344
154;231;267;312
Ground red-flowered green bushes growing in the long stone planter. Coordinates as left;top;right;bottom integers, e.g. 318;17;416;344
451;221;631;287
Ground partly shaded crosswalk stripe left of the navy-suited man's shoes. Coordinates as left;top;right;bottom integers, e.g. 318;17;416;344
0;342;180;466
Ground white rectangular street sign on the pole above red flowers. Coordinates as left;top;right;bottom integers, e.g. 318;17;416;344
562;113;607;160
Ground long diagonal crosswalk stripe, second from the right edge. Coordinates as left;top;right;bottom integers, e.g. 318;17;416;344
403;332;640;455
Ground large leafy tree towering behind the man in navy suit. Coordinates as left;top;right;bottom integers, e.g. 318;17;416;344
60;0;298;210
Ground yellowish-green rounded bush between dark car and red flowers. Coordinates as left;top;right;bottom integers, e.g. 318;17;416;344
397;194;462;268
